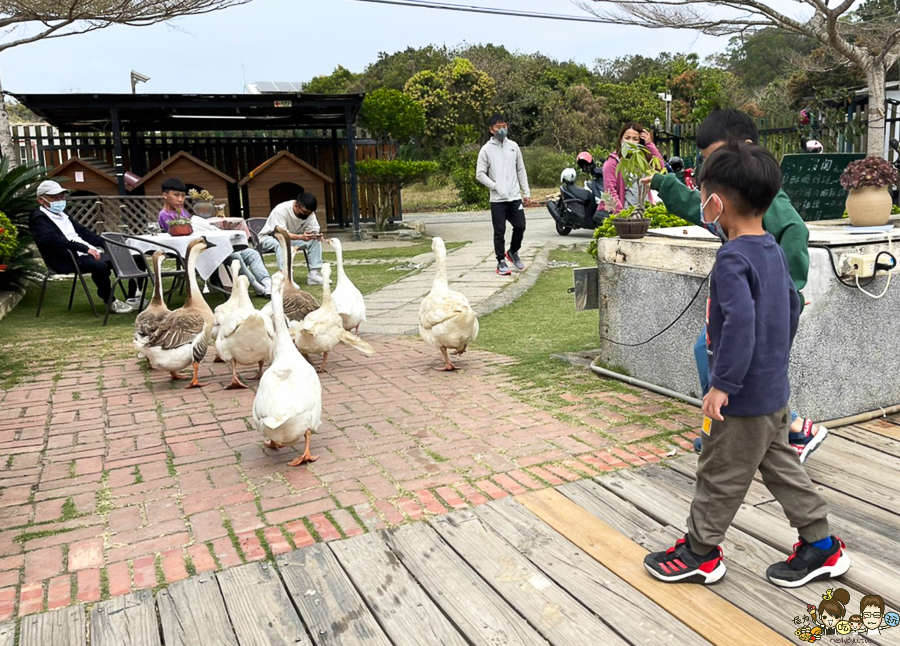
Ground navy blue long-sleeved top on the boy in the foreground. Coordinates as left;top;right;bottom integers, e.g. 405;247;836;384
708;233;800;416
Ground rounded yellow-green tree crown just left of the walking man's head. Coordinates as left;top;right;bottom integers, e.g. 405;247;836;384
405;58;496;149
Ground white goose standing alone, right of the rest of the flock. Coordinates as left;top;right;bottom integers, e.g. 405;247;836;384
419;238;478;370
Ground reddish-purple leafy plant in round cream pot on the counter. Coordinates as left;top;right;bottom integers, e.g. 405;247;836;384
841;157;897;227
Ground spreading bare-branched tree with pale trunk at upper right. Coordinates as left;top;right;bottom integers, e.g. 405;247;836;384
573;0;900;156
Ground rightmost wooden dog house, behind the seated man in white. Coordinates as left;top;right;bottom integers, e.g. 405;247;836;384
239;150;334;229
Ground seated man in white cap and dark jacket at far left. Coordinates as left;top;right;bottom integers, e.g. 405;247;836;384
28;180;145;314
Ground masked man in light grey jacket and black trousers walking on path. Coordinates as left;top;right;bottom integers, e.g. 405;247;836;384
475;114;531;276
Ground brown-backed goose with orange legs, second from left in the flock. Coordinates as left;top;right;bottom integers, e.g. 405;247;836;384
143;238;215;388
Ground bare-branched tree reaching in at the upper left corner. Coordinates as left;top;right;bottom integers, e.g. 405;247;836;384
0;0;250;166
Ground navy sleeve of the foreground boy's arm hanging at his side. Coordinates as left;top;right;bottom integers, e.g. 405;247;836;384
709;253;756;404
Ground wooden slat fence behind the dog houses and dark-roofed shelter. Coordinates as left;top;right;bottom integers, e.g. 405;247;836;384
13;124;400;223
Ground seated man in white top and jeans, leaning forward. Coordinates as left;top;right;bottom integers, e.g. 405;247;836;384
259;193;323;285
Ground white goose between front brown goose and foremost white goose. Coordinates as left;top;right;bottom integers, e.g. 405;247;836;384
213;260;275;390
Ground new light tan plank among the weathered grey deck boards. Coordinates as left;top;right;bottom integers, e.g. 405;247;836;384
516;489;791;646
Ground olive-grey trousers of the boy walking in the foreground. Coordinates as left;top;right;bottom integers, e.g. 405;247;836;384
688;406;830;555
